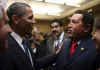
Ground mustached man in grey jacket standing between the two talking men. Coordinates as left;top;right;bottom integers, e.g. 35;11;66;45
46;19;68;70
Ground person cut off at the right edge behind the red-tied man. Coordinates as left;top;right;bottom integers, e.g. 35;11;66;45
93;19;100;70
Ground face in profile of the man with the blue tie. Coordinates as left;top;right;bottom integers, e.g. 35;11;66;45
16;7;35;35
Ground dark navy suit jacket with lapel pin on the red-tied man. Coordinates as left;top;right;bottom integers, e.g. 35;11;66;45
56;37;96;70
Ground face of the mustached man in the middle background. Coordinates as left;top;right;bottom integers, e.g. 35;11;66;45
51;22;61;36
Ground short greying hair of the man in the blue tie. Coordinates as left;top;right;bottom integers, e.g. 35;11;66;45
7;2;30;21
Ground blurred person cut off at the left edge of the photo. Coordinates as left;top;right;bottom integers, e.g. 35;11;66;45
0;6;12;70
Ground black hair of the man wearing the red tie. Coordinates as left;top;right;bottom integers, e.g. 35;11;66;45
74;10;94;33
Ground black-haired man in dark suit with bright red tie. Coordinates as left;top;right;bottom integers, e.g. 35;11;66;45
56;10;96;70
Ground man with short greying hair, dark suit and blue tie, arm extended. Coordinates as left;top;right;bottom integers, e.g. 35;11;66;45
5;2;56;70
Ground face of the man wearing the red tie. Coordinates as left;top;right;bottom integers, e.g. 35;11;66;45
68;14;85;38
